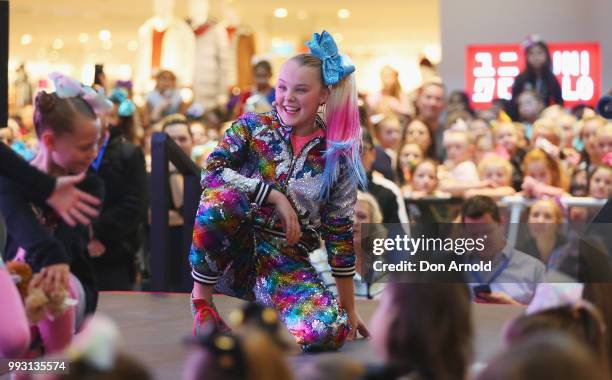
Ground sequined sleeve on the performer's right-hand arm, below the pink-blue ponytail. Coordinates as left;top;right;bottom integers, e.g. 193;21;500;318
321;159;357;277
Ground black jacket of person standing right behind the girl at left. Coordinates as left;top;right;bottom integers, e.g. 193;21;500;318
92;128;147;265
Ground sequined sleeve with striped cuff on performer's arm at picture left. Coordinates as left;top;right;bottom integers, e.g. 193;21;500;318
201;119;272;205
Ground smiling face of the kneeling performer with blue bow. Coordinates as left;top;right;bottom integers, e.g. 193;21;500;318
276;59;329;131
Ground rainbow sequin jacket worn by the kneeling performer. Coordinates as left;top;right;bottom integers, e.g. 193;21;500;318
201;111;357;277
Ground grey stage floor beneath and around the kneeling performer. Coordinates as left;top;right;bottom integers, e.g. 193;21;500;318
93;292;522;380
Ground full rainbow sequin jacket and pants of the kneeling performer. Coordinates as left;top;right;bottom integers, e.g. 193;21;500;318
189;112;357;351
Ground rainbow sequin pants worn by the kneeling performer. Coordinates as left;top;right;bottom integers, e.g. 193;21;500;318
189;188;349;351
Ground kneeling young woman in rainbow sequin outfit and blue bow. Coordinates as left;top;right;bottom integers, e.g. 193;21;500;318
189;31;369;351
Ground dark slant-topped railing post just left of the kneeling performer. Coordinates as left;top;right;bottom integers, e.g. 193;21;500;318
150;132;201;291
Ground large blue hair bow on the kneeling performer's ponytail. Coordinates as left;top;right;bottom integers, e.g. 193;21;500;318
306;30;355;86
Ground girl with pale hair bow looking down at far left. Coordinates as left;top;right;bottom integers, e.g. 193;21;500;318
0;73;107;354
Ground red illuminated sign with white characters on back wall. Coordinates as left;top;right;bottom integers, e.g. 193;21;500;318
465;43;601;109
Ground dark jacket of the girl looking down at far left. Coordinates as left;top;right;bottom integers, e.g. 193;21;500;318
0;176;104;313
